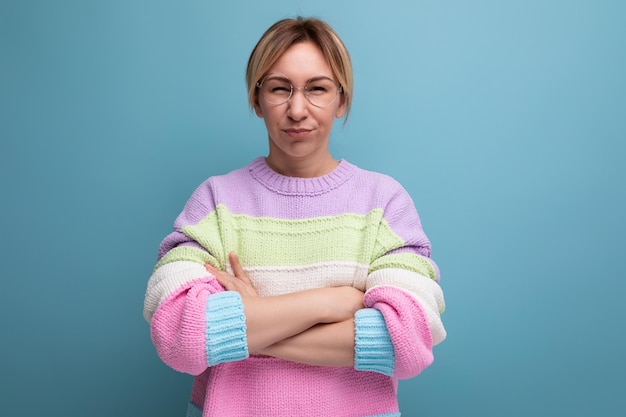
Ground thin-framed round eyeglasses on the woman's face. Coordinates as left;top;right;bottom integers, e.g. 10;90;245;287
256;73;343;107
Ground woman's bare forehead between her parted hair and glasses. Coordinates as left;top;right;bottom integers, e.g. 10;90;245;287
268;42;333;82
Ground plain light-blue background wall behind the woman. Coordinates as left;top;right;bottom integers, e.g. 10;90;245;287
0;0;626;417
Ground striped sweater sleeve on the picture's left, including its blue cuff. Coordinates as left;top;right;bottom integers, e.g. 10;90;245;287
144;180;248;375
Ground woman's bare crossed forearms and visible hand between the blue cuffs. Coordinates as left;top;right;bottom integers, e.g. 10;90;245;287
206;252;364;366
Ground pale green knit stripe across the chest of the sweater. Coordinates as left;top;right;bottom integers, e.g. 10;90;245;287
159;205;404;267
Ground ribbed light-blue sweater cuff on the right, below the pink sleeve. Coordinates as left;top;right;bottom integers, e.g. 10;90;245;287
354;308;395;376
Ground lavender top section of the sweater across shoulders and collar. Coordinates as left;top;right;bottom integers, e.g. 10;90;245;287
159;158;439;281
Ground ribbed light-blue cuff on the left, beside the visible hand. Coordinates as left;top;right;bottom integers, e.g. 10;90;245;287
206;291;248;366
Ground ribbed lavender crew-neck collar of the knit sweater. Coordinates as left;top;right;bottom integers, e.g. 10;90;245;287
248;157;356;196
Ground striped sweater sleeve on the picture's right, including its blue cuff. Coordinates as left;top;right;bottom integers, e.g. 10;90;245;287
355;182;446;379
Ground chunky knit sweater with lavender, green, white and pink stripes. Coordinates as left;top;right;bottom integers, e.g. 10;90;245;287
144;158;446;417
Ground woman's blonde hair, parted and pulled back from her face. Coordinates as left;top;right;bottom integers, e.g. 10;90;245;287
246;17;353;122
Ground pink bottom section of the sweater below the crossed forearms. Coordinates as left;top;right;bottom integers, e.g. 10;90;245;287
191;356;398;417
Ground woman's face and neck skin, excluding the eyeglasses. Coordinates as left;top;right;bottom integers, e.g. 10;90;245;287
254;42;345;176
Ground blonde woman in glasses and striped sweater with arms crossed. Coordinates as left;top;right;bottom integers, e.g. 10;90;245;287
144;18;445;417
